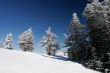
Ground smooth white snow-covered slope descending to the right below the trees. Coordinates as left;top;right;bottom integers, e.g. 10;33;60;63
0;48;99;73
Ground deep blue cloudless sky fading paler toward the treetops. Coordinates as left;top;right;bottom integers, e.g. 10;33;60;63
0;0;87;52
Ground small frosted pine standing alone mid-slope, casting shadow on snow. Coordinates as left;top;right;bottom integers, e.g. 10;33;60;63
40;27;60;55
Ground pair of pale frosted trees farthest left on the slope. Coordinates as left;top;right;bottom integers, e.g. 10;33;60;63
0;28;33;51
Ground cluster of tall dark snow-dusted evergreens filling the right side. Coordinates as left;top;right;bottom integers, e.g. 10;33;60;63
65;0;110;72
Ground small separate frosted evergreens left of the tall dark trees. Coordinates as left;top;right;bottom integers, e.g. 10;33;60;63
0;27;60;55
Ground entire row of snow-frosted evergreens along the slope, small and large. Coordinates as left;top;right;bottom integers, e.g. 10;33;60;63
0;0;110;72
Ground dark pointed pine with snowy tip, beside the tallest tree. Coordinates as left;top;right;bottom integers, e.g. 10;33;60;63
65;13;86;62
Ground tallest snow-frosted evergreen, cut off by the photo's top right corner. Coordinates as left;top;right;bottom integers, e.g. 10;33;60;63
84;0;110;71
